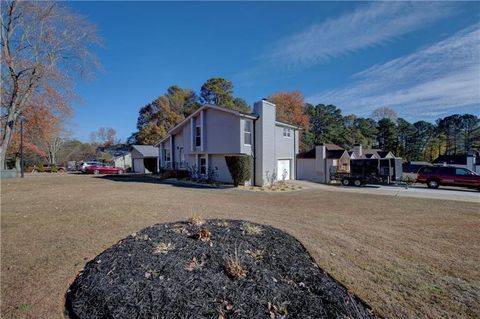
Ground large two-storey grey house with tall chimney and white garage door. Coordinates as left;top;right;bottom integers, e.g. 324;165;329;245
159;100;299;186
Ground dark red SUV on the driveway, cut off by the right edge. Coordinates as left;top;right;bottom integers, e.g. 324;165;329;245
417;166;480;190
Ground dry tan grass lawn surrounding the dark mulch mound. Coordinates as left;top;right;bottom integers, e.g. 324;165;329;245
1;175;480;318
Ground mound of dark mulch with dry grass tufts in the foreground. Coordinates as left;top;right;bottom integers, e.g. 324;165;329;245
66;220;373;319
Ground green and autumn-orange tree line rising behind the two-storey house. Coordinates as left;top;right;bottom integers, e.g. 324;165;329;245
128;78;480;161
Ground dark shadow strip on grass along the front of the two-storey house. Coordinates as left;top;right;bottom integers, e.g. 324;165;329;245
95;174;233;189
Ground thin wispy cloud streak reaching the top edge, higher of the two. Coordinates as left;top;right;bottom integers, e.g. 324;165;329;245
263;2;453;69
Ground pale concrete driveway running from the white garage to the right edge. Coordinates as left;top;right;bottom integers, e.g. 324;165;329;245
291;180;480;204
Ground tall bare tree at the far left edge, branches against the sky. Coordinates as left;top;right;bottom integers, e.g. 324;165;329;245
0;1;99;169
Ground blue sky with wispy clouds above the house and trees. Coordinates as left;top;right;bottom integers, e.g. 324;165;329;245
69;2;480;141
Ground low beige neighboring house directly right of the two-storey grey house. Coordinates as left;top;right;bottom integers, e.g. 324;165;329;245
297;144;356;183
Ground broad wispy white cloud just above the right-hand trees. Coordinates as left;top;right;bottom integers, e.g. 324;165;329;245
307;25;480;119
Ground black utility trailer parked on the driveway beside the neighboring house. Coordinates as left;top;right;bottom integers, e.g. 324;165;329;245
335;157;402;186
